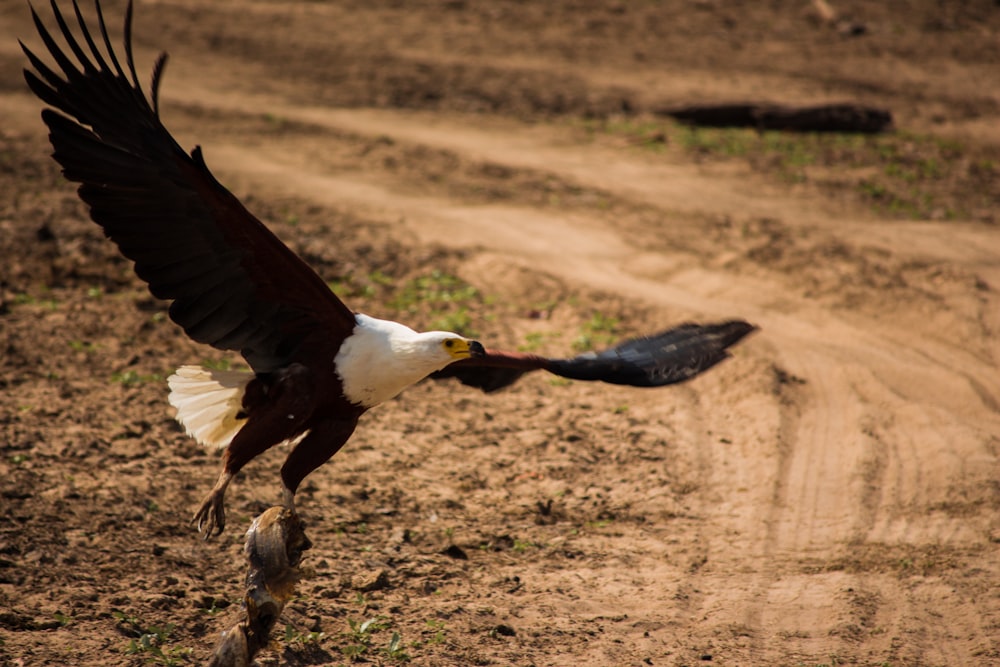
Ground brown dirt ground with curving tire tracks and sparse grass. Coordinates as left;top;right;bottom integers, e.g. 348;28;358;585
0;0;1000;667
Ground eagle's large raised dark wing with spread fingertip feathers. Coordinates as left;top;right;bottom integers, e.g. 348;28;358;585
21;0;355;372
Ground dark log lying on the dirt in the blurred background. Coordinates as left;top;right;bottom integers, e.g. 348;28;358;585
657;103;892;134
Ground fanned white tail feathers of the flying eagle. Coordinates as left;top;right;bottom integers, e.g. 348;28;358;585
167;366;253;449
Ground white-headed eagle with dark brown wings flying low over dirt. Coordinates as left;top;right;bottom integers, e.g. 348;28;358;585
19;0;755;539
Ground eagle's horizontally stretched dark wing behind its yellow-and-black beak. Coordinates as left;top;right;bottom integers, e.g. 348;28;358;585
432;320;756;392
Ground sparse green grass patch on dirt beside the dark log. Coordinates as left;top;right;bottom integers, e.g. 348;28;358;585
585;118;1000;222
